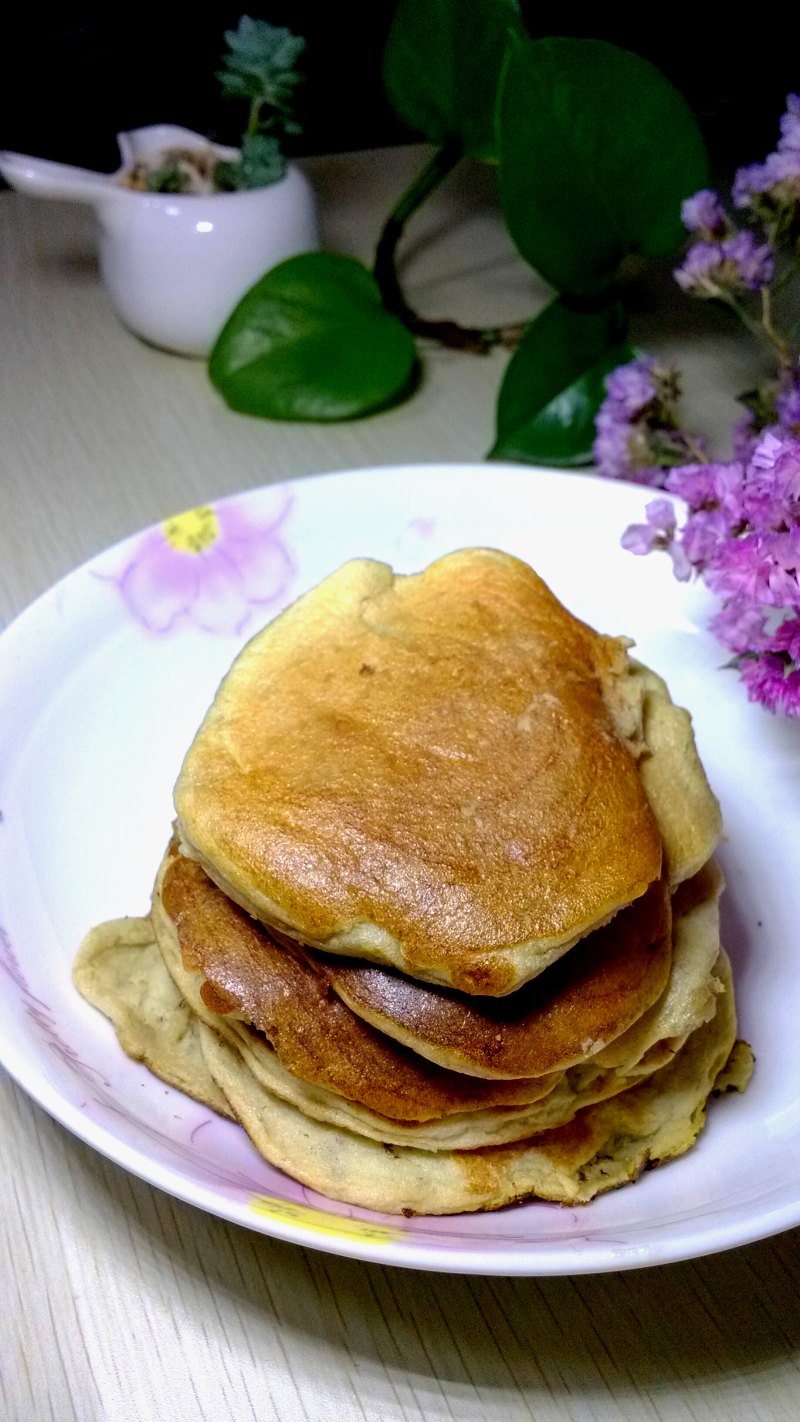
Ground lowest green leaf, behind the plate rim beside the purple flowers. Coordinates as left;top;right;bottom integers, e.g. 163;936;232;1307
489;297;634;465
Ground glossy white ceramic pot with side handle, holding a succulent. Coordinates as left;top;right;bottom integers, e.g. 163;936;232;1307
0;124;320;356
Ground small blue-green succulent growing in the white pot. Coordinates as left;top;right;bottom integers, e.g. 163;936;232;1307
148;14;306;192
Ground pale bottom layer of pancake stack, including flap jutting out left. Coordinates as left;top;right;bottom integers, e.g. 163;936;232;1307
74;919;750;1214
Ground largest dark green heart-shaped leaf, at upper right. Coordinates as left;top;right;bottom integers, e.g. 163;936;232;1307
499;34;708;294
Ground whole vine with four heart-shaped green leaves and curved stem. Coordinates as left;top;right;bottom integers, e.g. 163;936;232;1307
209;0;708;455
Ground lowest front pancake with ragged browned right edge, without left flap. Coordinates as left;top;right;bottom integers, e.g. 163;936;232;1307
202;957;752;1214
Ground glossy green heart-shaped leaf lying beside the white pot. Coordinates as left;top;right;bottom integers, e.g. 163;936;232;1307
209;252;416;421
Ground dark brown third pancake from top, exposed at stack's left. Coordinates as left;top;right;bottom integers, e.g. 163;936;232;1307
144;852;718;1150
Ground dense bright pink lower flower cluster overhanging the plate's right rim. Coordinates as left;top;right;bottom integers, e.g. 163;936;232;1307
622;434;800;715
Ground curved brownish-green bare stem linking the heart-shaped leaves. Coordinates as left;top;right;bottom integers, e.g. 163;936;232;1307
372;139;526;356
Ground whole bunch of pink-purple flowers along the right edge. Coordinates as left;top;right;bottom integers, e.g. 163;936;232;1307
594;94;800;715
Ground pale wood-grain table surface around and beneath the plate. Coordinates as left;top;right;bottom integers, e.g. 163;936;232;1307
0;148;800;1422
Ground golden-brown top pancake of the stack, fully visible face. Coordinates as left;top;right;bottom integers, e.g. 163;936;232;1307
175;549;661;995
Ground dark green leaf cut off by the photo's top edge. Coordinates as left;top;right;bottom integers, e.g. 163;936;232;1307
384;0;519;161
